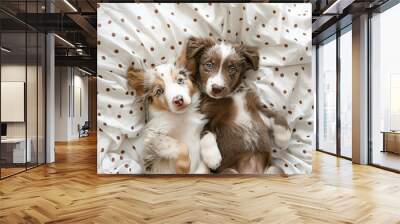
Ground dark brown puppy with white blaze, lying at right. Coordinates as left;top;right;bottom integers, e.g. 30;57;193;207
186;37;291;174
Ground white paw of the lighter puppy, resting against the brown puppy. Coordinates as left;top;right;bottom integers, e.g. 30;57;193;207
200;132;222;170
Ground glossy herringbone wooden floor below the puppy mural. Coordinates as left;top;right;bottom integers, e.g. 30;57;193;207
0;138;400;224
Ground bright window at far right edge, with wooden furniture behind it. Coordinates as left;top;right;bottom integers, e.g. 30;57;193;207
370;4;400;170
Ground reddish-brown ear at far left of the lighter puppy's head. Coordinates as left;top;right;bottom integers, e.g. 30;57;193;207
127;67;153;96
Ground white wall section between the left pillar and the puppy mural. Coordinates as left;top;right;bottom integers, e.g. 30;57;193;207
55;67;88;141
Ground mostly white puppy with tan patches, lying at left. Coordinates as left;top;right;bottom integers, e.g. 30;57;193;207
128;64;221;174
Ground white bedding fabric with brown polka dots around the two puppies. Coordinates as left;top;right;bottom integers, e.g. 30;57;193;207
97;3;314;174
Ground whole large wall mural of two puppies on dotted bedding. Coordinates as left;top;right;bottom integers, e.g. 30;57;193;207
97;3;314;175
